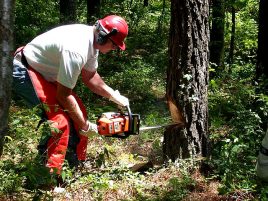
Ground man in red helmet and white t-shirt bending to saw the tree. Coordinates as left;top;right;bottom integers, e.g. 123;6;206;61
13;15;129;173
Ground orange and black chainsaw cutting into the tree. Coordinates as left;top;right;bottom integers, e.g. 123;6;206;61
97;106;178;139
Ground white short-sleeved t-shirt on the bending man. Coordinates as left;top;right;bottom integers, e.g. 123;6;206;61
23;24;99;89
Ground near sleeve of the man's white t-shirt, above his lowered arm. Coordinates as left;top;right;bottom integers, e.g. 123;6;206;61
57;51;85;89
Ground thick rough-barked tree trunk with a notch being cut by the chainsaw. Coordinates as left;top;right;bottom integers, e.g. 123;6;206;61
163;0;209;161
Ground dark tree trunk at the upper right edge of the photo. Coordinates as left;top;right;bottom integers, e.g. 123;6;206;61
256;0;268;95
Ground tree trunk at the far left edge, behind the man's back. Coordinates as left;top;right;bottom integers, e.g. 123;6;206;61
0;0;15;156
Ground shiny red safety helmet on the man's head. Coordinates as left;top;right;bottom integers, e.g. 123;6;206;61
98;15;128;50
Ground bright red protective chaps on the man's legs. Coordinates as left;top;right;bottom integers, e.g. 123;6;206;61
28;67;88;174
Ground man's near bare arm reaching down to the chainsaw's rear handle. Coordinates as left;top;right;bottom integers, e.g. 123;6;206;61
56;83;89;130
